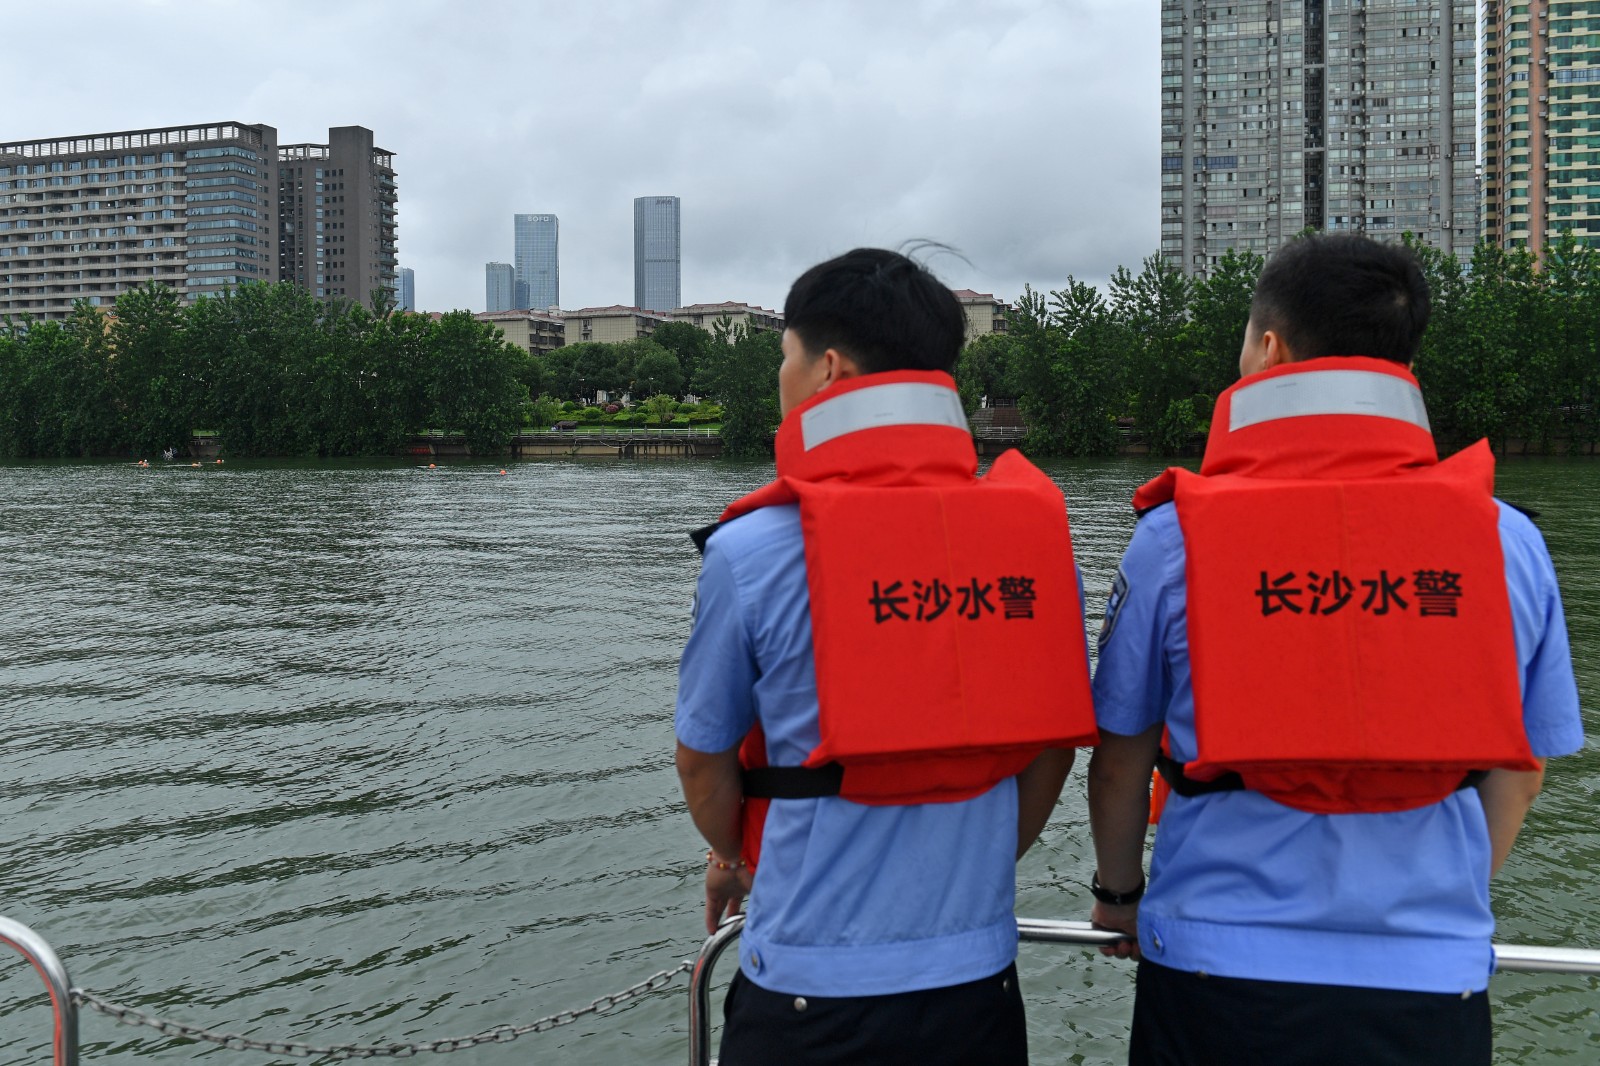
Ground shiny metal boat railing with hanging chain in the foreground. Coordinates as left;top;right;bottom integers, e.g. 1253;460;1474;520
9;916;1600;1066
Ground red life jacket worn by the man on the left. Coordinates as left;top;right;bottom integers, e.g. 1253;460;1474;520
722;371;1098;864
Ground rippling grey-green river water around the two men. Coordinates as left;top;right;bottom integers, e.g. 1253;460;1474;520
0;459;1600;1064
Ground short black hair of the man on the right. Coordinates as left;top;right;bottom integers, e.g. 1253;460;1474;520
1250;234;1429;363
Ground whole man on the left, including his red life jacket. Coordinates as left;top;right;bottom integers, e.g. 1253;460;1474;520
675;248;1094;1066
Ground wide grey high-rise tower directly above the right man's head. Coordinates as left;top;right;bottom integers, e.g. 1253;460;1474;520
1162;0;1478;274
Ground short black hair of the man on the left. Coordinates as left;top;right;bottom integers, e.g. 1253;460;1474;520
784;248;966;375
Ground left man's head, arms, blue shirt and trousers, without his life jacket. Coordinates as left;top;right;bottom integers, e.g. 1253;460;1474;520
675;250;1072;1066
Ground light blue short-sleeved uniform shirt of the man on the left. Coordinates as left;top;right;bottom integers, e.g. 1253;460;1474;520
674;506;1018;996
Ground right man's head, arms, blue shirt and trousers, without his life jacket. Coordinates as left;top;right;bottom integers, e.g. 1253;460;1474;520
1088;237;1582;1066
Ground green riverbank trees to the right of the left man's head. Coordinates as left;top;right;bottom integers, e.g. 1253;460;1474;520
957;235;1600;456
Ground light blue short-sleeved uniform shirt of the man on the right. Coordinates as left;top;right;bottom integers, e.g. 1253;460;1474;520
1094;504;1582;992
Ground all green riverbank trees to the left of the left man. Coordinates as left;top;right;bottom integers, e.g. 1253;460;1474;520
0;283;778;458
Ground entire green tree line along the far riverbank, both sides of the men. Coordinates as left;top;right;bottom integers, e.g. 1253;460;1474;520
0;235;1600;458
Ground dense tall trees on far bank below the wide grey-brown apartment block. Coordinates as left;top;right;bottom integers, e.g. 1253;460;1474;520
0;283;538;458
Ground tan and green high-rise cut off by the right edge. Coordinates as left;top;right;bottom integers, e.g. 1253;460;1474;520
1483;0;1600;251
